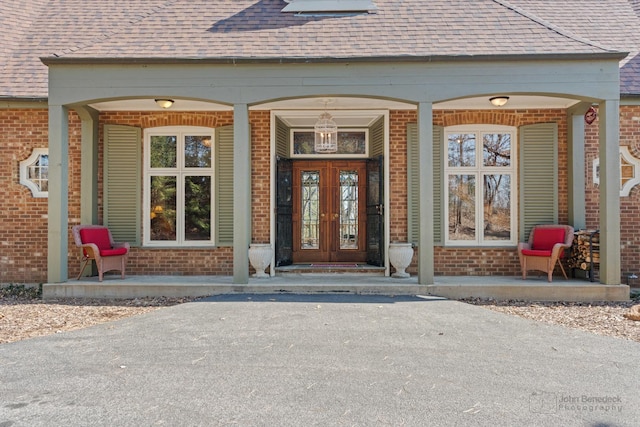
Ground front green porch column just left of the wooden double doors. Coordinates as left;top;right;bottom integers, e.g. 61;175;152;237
233;104;251;284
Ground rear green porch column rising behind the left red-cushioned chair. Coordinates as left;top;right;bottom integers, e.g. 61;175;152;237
76;107;100;224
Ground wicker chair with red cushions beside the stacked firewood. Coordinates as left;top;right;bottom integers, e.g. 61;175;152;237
518;225;573;282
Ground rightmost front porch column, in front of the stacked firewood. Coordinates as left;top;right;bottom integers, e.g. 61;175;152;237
598;99;620;285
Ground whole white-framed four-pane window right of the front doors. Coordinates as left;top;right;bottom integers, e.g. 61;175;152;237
445;126;517;246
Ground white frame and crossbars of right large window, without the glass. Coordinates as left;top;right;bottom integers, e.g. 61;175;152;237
441;124;518;247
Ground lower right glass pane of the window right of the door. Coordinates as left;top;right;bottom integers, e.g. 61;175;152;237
484;175;511;241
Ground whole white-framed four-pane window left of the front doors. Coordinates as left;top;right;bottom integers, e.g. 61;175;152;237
143;127;215;246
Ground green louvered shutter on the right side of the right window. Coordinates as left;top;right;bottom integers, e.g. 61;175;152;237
520;123;558;241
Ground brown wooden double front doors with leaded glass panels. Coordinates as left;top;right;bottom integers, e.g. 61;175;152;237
292;160;367;263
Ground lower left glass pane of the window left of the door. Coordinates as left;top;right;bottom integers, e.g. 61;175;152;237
149;176;177;240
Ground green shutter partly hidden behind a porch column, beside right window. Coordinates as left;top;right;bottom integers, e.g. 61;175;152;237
407;123;444;244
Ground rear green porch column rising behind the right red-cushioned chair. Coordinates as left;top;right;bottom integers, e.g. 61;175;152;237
567;102;591;230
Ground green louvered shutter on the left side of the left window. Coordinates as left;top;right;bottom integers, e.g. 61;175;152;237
103;125;142;245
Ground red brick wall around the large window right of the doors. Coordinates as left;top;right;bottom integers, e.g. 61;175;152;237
389;110;568;276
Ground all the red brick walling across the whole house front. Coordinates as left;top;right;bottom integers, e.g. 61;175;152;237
0;106;640;283
